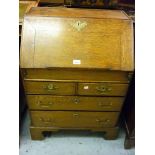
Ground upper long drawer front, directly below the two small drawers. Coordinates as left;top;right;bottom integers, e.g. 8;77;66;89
27;95;124;111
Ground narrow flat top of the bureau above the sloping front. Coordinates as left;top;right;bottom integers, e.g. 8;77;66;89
28;7;129;20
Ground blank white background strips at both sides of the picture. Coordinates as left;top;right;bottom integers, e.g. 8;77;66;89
0;0;155;155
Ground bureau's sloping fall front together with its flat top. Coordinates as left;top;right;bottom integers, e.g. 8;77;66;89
20;8;134;71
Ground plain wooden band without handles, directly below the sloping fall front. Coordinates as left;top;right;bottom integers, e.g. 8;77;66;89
22;68;132;83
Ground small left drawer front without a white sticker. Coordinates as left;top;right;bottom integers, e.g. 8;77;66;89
24;81;75;95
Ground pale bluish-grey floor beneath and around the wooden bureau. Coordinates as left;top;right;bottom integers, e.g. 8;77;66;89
19;111;135;155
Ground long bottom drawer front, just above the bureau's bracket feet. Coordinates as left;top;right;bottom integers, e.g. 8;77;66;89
30;111;119;128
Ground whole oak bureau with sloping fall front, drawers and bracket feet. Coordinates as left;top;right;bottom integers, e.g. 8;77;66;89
20;7;134;140
